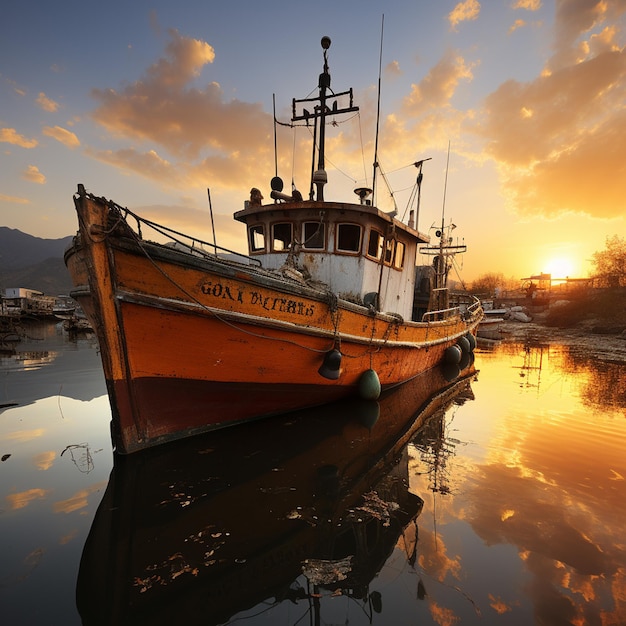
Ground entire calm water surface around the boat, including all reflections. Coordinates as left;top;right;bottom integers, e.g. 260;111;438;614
0;326;626;626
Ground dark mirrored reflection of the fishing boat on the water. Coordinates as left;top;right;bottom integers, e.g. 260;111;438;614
77;366;475;624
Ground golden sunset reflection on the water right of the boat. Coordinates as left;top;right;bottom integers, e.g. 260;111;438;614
412;342;626;624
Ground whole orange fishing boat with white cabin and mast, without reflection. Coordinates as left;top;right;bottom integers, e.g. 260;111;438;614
65;37;482;453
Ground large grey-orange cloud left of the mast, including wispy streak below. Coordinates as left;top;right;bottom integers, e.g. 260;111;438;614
88;30;272;193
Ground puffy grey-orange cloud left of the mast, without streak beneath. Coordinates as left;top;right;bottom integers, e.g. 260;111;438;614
92;30;271;159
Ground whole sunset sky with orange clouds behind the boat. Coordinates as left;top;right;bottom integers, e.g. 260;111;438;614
0;0;626;281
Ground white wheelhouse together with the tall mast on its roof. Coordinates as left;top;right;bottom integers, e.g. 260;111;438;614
234;37;429;320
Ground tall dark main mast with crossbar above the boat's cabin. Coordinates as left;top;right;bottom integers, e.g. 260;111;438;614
291;37;359;202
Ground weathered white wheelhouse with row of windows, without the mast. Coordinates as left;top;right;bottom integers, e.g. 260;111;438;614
234;190;429;320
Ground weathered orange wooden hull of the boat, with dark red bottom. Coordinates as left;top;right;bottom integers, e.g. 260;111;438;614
66;188;480;452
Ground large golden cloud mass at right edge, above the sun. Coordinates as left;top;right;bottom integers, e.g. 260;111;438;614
475;44;626;218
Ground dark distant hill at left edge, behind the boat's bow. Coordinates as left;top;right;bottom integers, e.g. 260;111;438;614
0;226;72;296
